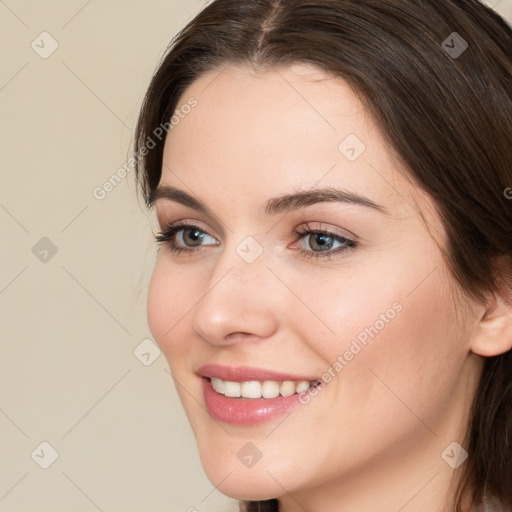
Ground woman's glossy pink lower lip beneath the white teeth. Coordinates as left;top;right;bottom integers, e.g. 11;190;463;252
201;377;300;426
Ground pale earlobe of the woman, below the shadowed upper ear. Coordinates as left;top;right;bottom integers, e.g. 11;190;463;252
471;290;512;357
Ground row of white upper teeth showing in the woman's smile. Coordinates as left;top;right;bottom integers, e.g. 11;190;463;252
210;377;310;398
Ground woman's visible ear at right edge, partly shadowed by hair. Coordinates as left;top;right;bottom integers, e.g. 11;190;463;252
470;257;512;357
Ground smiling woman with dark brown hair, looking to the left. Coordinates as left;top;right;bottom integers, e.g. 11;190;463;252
135;0;512;512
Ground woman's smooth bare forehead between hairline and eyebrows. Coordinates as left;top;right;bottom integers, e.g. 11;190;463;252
162;64;428;220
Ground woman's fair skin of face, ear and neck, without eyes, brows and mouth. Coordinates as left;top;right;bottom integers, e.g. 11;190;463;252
148;65;512;512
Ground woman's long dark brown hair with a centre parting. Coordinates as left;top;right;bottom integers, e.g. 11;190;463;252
134;0;512;512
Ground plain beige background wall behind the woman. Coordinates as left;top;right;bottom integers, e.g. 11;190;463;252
0;0;512;512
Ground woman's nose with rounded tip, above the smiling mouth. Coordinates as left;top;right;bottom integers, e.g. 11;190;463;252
192;242;283;346
